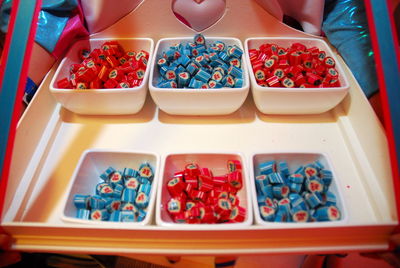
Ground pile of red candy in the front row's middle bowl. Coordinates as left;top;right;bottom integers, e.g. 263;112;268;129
166;160;246;224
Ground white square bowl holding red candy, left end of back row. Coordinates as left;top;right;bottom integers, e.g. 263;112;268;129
50;38;154;115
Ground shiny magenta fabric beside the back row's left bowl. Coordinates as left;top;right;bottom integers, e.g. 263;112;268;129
52;12;89;59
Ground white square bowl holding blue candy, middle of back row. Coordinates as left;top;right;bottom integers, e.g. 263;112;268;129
149;37;250;115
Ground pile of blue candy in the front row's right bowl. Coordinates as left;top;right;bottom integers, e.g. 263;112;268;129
255;161;341;222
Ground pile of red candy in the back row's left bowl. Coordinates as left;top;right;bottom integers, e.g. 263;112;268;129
57;41;149;89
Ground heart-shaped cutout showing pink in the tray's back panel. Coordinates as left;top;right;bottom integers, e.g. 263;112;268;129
172;0;226;32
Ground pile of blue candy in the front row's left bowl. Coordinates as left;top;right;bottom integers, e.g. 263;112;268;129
74;163;154;222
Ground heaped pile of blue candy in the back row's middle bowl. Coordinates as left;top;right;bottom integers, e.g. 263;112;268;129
157;34;243;89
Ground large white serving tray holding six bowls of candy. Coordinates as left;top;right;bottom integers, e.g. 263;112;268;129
1;0;397;255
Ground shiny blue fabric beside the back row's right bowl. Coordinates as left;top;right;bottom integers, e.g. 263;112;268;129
322;0;378;98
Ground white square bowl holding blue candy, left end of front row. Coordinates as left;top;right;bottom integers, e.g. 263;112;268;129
61;149;160;226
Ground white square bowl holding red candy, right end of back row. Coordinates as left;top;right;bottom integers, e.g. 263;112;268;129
245;37;350;114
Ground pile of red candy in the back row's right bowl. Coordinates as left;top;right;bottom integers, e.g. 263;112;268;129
249;43;340;88
